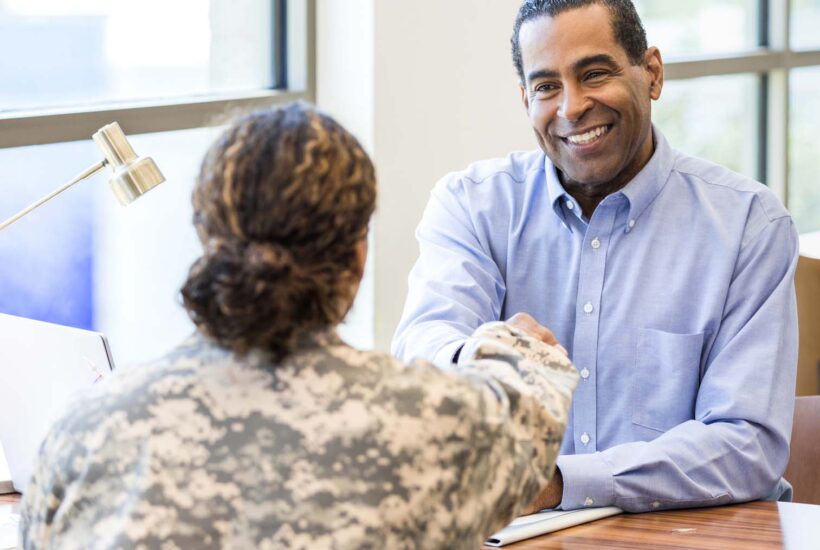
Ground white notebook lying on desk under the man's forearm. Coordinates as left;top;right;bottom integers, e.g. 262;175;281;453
485;506;622;546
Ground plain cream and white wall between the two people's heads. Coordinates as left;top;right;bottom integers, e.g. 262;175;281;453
316;0;535;349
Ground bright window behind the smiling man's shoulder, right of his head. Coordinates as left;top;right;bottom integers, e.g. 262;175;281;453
635;0;820;233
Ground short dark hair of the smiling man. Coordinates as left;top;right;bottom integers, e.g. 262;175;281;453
510;0;647;83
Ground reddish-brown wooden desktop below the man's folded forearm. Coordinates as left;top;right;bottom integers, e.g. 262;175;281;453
496;502;820;550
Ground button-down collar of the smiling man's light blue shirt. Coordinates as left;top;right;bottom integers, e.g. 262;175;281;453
544;125;674;231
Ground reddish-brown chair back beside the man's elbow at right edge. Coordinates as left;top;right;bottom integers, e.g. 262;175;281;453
784;395;820;504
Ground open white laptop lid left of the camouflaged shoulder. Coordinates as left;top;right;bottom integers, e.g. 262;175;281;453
0;314;114;493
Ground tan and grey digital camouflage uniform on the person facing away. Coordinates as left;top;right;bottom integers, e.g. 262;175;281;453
20;323;577;549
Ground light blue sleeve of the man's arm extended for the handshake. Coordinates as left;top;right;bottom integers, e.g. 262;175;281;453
392;175;506;366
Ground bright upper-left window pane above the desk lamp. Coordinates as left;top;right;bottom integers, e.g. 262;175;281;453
0;0;281;110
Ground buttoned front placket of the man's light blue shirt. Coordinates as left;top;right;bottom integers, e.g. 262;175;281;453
572;203;617;454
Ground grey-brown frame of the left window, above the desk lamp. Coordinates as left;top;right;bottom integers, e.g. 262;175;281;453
0;0;316;148
